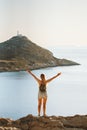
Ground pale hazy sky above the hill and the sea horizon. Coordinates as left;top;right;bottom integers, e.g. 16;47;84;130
0;0;87;46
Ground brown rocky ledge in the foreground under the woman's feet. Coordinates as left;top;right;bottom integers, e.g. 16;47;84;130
0;115;87;130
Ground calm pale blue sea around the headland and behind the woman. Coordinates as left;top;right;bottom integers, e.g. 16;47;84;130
0;46;87;120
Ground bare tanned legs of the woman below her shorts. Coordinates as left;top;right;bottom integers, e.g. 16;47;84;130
38;97;47;116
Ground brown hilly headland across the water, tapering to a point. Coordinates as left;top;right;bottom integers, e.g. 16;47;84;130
0;36;79;71
